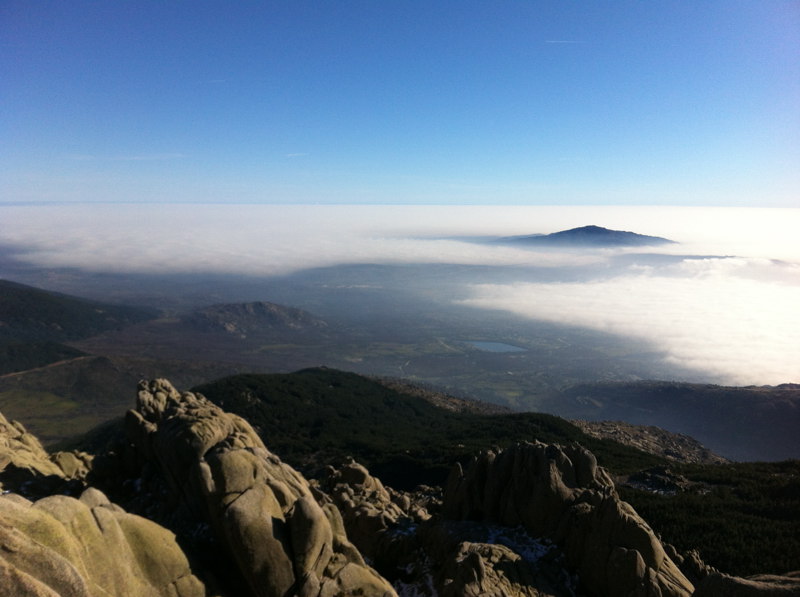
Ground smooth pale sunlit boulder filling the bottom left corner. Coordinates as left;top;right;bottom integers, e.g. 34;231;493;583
0;489;206;597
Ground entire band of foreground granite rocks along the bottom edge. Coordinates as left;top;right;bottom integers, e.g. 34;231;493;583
0;380;800;597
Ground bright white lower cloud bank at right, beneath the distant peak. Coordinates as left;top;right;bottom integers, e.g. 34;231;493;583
463;272;800;385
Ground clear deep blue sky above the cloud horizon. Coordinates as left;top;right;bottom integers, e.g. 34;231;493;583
0;0;800;207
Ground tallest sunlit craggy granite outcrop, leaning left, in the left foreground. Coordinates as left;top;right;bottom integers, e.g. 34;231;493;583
126;380;395;597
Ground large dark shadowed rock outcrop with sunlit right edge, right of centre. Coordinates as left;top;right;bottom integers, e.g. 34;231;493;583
443;442;694;597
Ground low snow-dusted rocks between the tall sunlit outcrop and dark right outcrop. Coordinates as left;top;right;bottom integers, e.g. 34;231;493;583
321;461;574;597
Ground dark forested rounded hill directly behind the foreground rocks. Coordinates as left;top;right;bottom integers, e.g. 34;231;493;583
189;368;658;489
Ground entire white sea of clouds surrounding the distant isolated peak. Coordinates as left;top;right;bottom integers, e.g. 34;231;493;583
0;204;800;384
